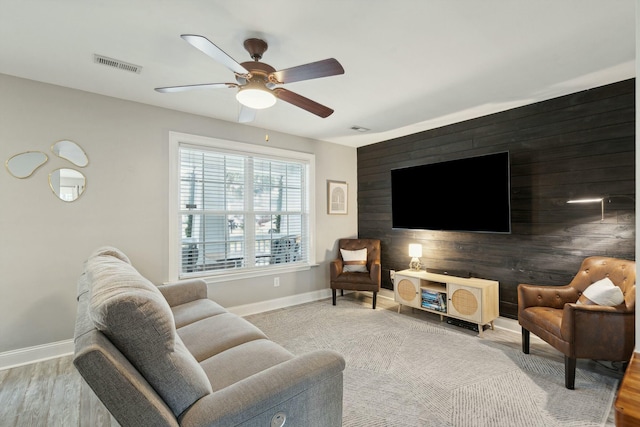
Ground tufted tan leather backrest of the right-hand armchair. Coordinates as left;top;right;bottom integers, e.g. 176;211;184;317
569;256;636;310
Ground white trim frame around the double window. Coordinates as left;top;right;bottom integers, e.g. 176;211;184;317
168;131;316;283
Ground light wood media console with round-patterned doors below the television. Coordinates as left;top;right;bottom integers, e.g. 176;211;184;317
393;270;499;337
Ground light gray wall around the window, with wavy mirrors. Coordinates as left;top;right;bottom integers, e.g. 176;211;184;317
0;75;357;353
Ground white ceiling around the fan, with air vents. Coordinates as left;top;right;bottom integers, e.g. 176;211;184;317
0;0;636;147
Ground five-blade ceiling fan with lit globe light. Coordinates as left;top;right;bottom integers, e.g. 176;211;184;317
155;34;344;122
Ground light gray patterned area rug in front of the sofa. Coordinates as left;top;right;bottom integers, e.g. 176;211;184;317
242;298;618;427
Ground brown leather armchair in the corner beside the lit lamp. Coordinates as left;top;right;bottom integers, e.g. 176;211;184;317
330;239;382;309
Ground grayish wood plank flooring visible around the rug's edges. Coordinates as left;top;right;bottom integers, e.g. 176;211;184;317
0;294;622;427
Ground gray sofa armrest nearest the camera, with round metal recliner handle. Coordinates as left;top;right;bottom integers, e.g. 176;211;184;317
180;350;345;427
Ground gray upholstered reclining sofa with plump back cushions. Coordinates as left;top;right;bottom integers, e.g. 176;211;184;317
74;247;345;427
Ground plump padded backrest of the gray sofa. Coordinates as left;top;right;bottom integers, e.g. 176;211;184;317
86;253;212;417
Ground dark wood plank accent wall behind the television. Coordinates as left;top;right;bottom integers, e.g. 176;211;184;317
358;79;635;318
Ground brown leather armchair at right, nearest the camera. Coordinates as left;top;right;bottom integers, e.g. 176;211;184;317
518;256;636;389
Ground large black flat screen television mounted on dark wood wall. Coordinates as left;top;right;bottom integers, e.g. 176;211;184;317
391;151;511;233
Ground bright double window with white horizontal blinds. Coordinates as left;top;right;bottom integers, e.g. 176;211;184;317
170;133;314;278
